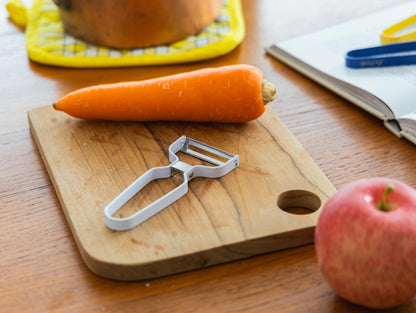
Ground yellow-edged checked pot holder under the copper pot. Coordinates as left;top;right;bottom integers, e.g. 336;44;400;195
8;0;245;67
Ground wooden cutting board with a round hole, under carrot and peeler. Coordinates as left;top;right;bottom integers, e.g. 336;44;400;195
28;106;335;280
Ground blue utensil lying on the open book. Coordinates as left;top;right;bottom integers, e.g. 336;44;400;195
345;41;416;68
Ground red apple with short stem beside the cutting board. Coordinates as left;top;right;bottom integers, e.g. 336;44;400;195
315;178;416;308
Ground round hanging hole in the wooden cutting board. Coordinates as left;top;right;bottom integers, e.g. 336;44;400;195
277;190;322;215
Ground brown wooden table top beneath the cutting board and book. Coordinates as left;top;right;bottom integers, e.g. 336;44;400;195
0;0;416;313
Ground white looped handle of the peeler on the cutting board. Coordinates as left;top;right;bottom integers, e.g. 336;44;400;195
104;163;189;231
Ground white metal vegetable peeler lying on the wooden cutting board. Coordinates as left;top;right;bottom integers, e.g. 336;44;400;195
104;136;239;231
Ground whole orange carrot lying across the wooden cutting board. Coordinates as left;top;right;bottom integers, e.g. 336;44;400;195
54;65;275;123
